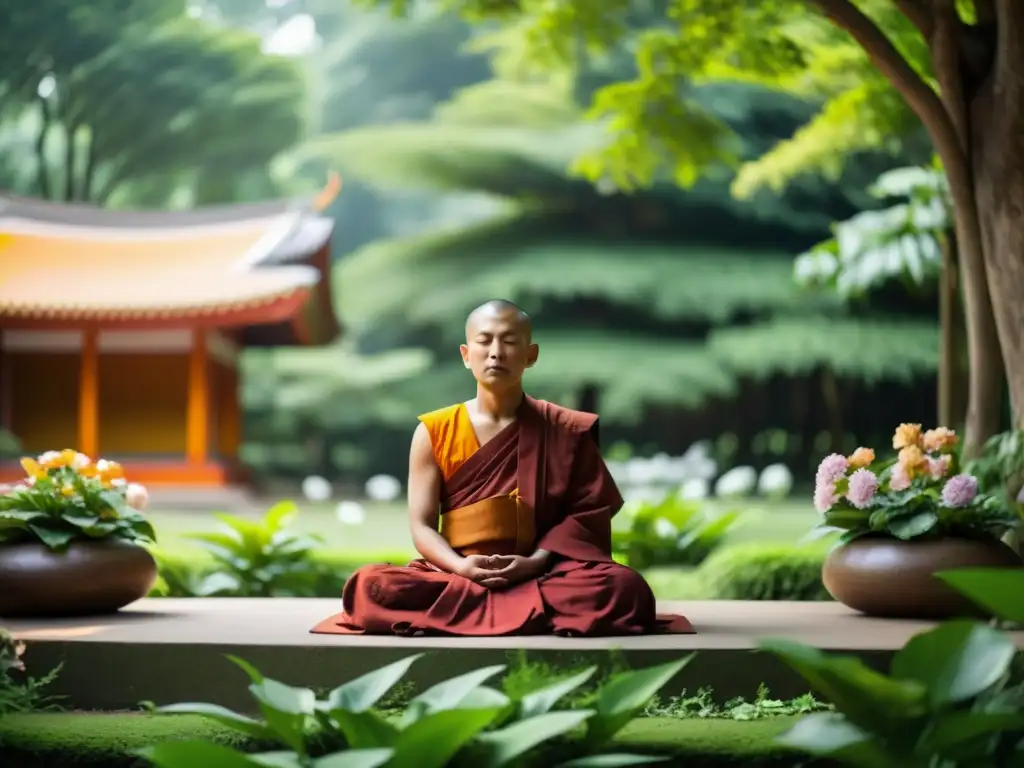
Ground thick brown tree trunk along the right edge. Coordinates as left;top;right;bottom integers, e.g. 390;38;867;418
972;50;1024;429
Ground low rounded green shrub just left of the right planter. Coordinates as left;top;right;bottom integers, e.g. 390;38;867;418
697;544;833;601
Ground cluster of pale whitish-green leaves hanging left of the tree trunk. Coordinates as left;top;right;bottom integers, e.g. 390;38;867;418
794;163;952;299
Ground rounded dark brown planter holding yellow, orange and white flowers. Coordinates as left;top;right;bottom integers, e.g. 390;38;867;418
0;540;157;618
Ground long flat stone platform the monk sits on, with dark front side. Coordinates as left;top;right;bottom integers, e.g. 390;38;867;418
9;598;1024;710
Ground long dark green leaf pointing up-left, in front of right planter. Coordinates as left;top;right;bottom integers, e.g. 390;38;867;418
760;639;927;734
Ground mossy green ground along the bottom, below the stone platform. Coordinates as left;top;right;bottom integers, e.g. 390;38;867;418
0;713;825;768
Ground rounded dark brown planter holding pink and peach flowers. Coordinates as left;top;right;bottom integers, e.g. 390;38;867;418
821;538;1024;620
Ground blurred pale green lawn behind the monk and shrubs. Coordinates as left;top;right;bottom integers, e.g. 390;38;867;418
152;498;816;555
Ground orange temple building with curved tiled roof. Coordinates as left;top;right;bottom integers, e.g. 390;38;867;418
0;179;340;488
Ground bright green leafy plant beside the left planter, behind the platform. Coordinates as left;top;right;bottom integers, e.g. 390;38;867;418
147;502;323;597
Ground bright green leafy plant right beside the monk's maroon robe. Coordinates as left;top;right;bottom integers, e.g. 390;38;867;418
612;494;743;569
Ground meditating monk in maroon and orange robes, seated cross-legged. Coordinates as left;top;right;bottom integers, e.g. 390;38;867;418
313;301;693;636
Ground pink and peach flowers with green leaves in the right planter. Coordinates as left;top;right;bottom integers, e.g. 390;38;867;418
814;424;1021;543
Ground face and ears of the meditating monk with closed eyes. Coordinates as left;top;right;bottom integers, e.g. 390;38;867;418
460;311;538;389
